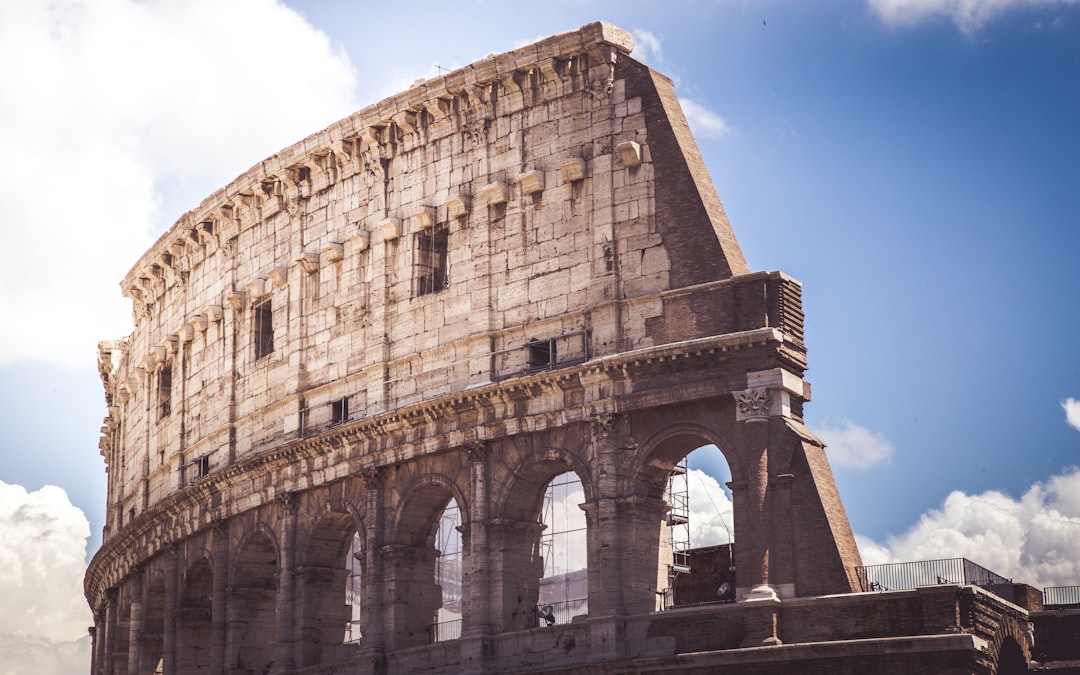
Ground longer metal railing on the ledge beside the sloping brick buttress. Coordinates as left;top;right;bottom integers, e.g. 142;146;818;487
855;558;1013;602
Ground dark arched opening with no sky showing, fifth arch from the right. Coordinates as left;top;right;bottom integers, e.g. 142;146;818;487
226;531;278;675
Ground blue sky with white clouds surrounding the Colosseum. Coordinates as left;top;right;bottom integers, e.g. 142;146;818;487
0;0;1080;665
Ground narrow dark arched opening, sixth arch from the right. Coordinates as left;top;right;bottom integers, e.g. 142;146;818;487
175;557;214;675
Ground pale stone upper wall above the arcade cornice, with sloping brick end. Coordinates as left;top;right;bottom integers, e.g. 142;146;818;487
99;23;781;531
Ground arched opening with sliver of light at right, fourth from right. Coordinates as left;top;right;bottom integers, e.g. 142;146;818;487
296;513;363;665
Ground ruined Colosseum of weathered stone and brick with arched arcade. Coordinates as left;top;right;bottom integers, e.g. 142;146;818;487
85;23;1049;675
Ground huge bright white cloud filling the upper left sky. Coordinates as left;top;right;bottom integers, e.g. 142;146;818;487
0;0;355;365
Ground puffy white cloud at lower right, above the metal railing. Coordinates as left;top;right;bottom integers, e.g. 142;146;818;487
859;468;1080;588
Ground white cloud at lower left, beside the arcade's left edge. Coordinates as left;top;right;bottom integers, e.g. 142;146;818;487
0;482;93;673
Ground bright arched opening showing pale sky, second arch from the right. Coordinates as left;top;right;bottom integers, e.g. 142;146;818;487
537;471;589;625
